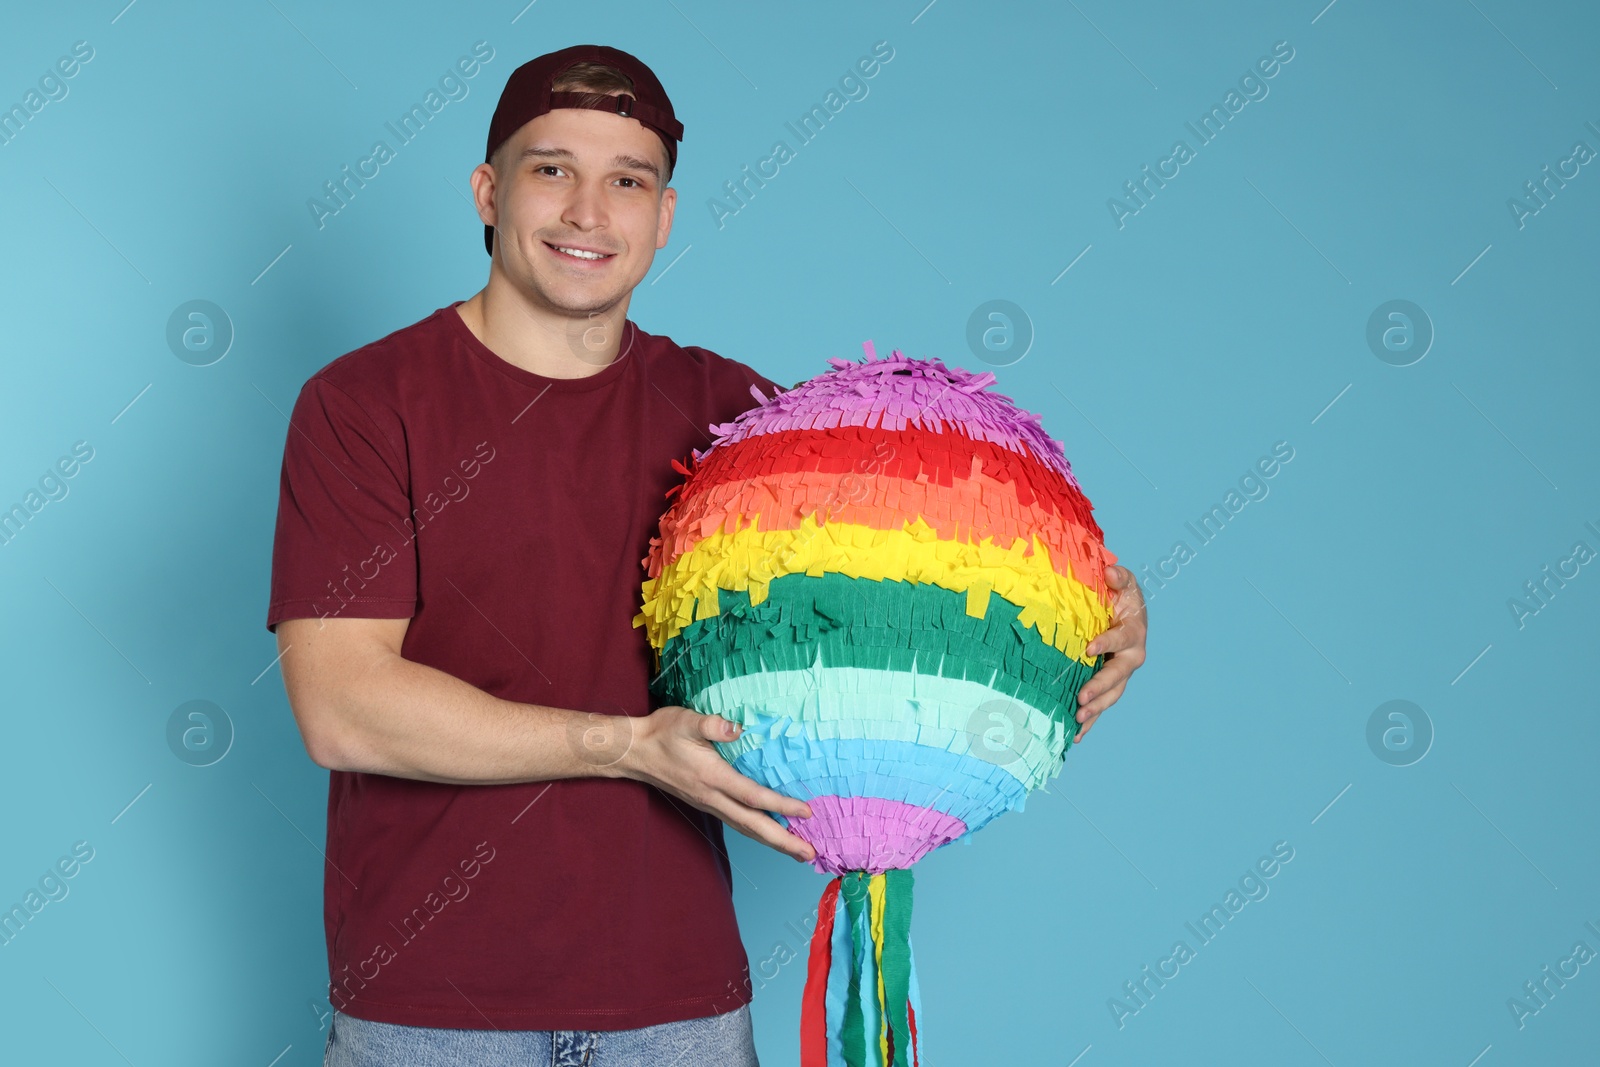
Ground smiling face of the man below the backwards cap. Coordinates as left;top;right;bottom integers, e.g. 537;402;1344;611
478;107;677;314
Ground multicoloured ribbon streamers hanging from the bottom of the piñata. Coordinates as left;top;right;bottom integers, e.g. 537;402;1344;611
800;869;922;1067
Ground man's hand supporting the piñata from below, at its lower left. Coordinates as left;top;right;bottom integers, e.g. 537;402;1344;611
611;705;816;862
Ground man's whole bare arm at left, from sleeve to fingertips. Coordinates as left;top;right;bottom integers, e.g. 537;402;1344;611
277;619;814;861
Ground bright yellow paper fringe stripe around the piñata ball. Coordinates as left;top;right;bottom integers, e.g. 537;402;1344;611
634;515;1112;662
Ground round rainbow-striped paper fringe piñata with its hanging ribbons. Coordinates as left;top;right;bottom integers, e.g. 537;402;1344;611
634;342;1115;1067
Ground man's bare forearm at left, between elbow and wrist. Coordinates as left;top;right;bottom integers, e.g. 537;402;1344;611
291;651;634;785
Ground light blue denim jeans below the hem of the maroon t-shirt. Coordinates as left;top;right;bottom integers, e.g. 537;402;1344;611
322;1005;760;1067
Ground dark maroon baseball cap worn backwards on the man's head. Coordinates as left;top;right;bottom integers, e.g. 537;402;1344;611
483;45;683;254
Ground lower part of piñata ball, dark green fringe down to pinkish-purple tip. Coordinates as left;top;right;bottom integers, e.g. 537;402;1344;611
653;573;1098;873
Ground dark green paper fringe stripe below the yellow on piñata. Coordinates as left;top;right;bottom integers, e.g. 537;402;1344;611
651;573;1099;733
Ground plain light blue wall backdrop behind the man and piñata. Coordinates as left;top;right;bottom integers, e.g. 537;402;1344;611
0;0;1600;1067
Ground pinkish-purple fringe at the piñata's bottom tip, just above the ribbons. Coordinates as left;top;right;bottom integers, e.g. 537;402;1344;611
789;797;966;875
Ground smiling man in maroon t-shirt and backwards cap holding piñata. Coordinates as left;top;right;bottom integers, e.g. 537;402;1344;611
267;45;1144;1067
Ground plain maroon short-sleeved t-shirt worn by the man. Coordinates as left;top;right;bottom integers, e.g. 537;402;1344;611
267;304;776;1030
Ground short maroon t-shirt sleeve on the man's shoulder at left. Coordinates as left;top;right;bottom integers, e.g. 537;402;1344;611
267;376;416;630
